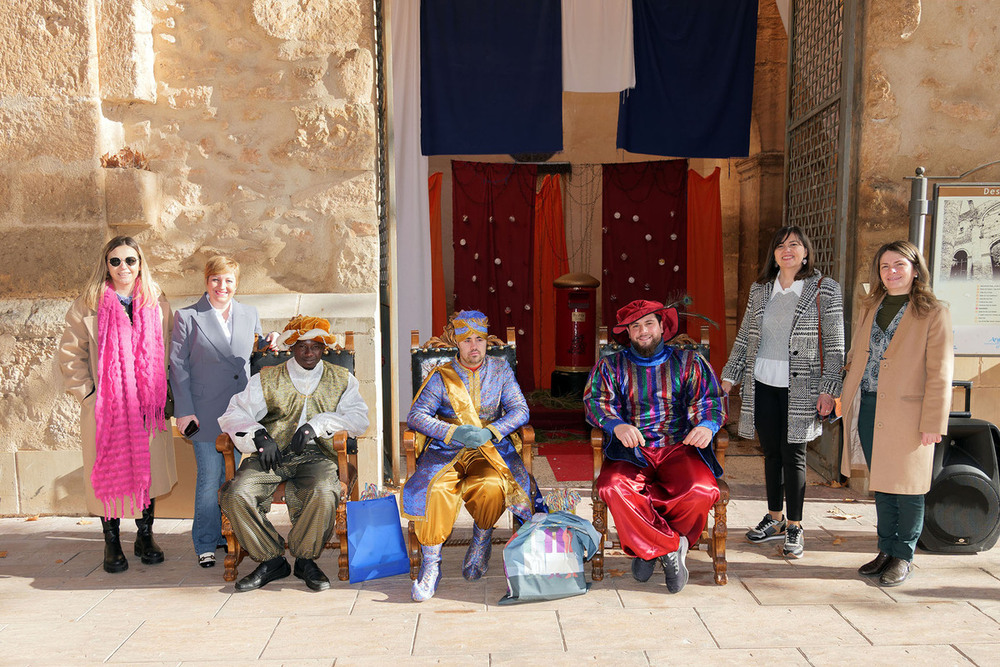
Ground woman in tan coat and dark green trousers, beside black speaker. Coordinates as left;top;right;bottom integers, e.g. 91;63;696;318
841;241;954;586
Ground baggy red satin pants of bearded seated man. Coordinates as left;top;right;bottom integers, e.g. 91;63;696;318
597;444;719;560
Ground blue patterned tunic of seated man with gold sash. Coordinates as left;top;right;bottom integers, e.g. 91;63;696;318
403;356;537;520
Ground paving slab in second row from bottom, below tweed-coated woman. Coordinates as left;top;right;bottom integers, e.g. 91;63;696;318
698;605;868;648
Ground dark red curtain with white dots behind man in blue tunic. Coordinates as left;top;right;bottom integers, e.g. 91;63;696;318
451;160;538;392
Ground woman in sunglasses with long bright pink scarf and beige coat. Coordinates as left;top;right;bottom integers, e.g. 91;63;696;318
58;236;177;573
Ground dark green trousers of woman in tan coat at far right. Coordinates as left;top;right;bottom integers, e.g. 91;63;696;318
858;391;924;560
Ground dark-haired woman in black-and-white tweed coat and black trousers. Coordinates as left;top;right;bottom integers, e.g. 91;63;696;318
722;226;844;558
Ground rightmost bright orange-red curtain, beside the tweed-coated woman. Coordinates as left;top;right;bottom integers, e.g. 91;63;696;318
687;167;726;374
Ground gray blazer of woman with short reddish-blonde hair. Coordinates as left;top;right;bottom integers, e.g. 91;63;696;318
170;293;261;441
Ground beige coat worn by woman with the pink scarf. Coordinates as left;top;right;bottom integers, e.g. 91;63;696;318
58;295;177;518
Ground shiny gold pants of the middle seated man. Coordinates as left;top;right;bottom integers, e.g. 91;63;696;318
414;449;507;546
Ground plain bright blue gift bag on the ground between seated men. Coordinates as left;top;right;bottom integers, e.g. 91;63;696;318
347;496;410;584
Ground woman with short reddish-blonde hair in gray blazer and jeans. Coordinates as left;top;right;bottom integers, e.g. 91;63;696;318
170;256;270;567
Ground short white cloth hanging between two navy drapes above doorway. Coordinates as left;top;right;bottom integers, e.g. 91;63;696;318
562;0;635;93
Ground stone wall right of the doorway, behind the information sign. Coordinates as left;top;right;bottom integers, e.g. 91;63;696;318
844;0;1000;423
